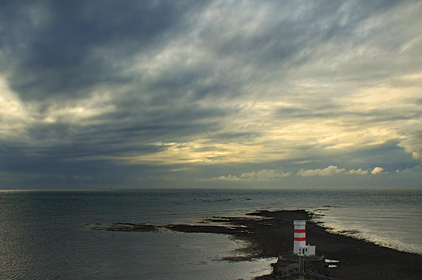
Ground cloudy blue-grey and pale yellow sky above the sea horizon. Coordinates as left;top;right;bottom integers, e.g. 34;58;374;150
0;0;422;189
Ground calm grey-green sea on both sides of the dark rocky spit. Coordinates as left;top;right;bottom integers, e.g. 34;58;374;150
0;188;422;280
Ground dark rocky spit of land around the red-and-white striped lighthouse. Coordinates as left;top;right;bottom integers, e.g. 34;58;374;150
83;210;422;280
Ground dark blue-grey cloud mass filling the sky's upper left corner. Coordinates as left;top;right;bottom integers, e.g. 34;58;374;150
1;1;209;100
